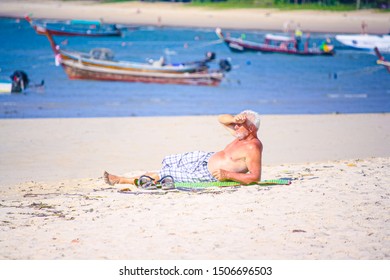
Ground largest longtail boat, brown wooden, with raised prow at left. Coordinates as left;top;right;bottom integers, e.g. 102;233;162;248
46;32;230;86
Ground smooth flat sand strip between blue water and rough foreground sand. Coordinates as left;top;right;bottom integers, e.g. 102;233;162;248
0;114;390;187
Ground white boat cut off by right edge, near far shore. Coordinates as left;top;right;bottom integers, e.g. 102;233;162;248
335;34;390;53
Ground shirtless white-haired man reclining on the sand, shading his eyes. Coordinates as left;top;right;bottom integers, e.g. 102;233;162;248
104;110;263;185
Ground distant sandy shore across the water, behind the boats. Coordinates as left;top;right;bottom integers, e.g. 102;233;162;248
0;0;390;34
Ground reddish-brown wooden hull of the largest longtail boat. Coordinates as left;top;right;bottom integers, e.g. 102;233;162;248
61;60;224;86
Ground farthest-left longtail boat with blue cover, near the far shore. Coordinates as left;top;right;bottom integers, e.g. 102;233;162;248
24;15;122;37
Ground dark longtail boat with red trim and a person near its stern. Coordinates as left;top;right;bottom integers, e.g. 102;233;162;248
215;28;334;56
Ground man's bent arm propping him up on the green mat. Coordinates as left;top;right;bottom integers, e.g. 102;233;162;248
213;145;263;185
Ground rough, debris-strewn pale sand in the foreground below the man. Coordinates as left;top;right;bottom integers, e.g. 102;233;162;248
0;158;390;260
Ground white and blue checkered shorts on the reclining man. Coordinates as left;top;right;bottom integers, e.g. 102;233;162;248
159;151;217;182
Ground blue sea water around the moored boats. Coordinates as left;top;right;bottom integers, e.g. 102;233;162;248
0;18;390;118
